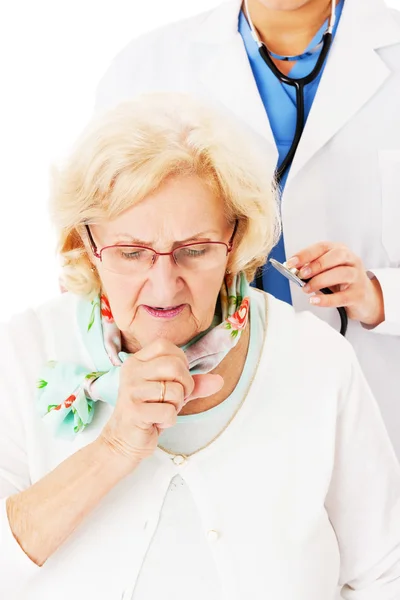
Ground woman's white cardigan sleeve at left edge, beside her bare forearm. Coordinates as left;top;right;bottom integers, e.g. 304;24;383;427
0;325;40;599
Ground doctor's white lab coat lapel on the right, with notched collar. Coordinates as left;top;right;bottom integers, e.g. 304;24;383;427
287;0;400;186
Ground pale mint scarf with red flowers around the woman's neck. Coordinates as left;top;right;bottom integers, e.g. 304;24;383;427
37;273;250;437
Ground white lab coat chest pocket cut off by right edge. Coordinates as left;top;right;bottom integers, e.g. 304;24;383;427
379;149;400;263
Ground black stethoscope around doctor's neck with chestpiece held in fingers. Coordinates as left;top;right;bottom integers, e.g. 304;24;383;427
244;0;348;335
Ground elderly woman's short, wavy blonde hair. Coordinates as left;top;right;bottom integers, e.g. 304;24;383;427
50;93;280;297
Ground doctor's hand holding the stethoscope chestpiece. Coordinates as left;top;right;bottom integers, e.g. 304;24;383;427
286;242;385;327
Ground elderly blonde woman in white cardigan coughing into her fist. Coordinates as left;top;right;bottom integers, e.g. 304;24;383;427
0;94;400;600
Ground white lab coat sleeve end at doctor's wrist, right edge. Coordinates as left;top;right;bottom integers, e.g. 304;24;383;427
367;268;400;336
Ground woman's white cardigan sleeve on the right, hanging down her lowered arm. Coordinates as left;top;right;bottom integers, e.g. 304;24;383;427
326;348;400;600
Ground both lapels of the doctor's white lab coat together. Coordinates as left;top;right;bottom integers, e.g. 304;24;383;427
190;0;400;185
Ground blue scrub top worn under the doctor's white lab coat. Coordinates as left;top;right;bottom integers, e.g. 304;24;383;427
239;0;344;304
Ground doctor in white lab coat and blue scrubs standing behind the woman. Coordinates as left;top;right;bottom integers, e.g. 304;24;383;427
97;0;400;457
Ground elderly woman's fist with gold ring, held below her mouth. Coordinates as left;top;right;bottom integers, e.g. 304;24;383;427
100;339;224;464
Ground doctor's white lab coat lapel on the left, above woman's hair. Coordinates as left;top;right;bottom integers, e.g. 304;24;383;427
195;0;278;164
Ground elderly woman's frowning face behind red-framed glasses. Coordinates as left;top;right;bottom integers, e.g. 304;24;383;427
91;176;232;352
